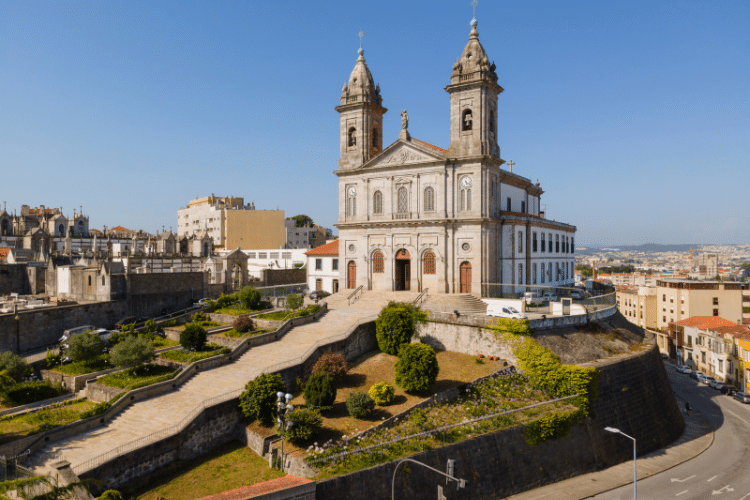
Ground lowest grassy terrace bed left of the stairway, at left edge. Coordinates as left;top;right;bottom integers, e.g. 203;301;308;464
0;399;94;444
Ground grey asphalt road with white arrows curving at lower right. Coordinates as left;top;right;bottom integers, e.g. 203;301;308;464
592;364;750;500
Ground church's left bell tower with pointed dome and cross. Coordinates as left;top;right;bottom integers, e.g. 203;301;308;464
336;39;388;170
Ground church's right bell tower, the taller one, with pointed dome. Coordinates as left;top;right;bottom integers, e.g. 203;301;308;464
445;18;503;159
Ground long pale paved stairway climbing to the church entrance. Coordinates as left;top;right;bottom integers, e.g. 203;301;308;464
26;291;418;472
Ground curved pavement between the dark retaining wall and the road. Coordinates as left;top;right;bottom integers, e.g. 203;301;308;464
507;409;714;500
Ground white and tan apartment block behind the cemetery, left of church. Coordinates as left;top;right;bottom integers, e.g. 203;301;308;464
177;195;286;250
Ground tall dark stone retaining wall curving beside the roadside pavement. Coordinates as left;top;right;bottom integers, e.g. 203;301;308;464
316;346;684;500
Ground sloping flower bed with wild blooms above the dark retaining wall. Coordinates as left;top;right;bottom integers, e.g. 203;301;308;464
308;370;575;479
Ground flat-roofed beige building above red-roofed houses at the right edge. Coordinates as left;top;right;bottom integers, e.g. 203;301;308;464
656;280;750;329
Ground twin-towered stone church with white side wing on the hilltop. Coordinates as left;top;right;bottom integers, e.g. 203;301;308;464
335;19;576;295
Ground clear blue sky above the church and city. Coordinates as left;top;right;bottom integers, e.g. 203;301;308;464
0;0;750;246
